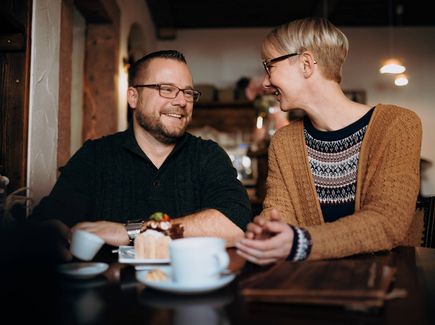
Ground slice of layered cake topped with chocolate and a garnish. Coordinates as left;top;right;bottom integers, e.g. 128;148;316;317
134;212;184;259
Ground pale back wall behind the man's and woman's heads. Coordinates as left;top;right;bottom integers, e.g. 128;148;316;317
157;27;435;195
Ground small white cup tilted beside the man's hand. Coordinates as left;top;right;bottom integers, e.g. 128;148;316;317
70;230;104;261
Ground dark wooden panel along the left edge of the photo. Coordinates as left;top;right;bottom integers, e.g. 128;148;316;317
0;0;32;192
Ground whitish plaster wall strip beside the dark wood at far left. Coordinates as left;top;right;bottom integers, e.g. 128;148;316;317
27;0;61;202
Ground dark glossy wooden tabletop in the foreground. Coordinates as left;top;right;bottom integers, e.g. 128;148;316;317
4;247;435;325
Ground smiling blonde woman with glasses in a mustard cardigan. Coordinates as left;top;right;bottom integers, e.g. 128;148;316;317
237;18;421;264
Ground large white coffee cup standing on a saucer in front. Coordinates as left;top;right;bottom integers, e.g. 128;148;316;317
169;237;230;286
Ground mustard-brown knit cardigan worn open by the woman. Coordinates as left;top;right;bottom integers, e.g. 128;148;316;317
264;104;422;259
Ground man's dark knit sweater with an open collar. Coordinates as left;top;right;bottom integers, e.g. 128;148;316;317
31;128;251;230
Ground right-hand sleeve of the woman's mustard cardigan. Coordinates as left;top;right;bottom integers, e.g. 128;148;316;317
306;111;422;259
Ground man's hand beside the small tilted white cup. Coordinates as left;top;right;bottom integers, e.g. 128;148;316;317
71;221;130;246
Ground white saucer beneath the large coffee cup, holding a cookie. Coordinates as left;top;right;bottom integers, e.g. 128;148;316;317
136;266;236;294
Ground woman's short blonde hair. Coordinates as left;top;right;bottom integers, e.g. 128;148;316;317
262;17;349;83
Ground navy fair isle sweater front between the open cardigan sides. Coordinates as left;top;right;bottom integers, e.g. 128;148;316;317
304;108;374;222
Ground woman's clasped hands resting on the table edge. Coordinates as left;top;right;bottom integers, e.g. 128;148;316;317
236;209;294;265
